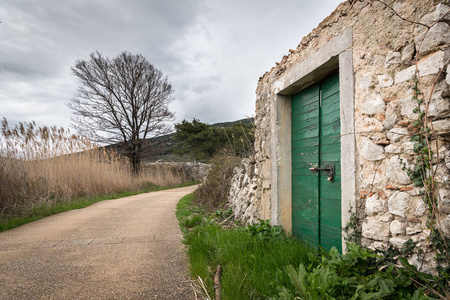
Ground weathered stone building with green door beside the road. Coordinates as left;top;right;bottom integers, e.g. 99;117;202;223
230;0;450;268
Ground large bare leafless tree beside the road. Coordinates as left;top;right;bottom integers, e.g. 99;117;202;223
68;51;174;174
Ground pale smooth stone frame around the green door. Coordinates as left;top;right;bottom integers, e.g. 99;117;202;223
271;27;356;252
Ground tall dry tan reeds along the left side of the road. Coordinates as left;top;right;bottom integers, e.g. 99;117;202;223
0;119;188;218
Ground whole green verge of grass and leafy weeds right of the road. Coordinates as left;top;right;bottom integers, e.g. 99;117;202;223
176;194;450;300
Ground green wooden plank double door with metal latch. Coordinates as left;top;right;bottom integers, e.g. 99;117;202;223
291;74;342;251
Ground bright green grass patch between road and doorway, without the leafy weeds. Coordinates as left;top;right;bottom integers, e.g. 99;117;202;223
177;195;316;300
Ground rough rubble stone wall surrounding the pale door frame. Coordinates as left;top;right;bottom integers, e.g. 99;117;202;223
230;0;450;272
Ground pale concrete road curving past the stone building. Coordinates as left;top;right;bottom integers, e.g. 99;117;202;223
0;186;196;299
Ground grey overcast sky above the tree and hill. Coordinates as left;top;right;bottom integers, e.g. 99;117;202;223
0;0;341;131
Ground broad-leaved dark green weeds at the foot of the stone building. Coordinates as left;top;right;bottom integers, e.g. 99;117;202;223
271;244;445;300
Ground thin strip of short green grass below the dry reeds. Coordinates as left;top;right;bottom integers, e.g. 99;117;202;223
0;182;197;232
